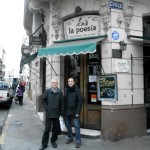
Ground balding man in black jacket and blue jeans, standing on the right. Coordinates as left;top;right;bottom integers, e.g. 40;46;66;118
65;78;82;148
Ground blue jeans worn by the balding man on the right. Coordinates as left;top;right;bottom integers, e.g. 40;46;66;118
65;116;81;143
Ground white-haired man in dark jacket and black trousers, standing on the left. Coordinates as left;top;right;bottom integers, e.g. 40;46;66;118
39;79;64;150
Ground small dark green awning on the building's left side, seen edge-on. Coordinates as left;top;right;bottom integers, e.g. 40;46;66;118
20;53;37;66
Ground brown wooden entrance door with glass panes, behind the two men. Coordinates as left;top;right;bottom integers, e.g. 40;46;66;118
65;53;101;130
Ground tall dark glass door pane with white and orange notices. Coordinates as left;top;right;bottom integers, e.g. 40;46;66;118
87;52;101;105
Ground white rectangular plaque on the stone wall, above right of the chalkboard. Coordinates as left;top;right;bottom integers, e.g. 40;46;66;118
114;59;129;72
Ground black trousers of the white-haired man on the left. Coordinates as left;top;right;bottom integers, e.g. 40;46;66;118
42;118;59;146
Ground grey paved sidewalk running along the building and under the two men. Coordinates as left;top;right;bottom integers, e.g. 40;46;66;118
0;92;150;150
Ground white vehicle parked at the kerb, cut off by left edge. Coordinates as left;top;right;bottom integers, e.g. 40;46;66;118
0;81;13;108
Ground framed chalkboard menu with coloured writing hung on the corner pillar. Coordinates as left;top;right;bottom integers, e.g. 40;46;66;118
97;74;118;101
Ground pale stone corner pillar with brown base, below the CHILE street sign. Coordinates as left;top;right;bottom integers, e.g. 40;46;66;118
100;0;146;141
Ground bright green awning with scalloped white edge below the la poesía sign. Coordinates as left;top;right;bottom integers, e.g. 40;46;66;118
38;35;107;57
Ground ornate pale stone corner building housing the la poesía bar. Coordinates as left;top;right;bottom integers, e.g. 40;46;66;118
24;0;150;140
